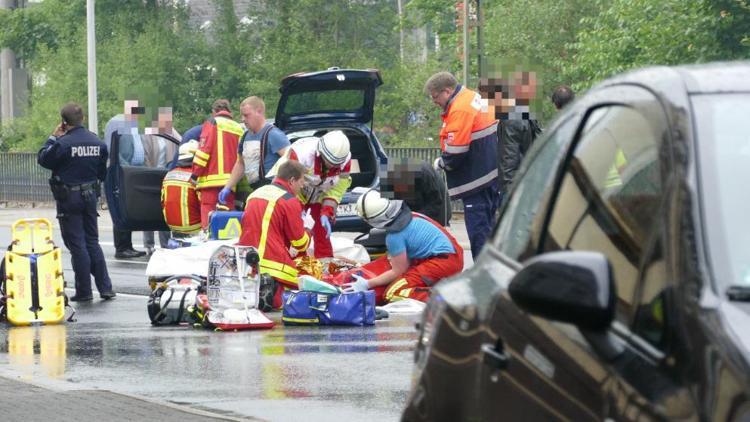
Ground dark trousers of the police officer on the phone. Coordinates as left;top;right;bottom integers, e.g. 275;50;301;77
57;190;112;296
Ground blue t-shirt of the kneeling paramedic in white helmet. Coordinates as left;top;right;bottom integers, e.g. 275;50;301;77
385;217;456;259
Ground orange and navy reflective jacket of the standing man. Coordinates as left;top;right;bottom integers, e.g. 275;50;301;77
440;85;498;199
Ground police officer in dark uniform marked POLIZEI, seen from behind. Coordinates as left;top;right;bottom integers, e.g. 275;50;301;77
37;103;115;302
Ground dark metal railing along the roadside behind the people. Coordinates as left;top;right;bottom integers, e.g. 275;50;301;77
0;148;463;212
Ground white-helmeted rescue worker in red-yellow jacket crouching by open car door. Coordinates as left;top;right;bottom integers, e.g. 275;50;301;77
161;140;201;234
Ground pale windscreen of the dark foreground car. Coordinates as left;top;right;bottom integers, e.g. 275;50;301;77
692;93;750;290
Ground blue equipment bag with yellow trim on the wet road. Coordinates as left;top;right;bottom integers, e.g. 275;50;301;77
281;291;375;326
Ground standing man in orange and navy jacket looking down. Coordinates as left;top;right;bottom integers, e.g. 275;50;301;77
425;72;500;259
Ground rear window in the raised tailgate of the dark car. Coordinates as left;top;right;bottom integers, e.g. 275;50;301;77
284;89;365;115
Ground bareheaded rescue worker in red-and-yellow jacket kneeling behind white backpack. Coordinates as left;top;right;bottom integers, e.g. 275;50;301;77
239;160;310;308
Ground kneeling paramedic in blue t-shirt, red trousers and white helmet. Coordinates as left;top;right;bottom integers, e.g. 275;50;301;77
344;190;464;304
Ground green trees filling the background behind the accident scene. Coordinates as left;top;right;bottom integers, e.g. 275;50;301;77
0;0;750;150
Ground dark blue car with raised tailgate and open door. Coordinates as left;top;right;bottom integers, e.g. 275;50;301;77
105;68;387;232
